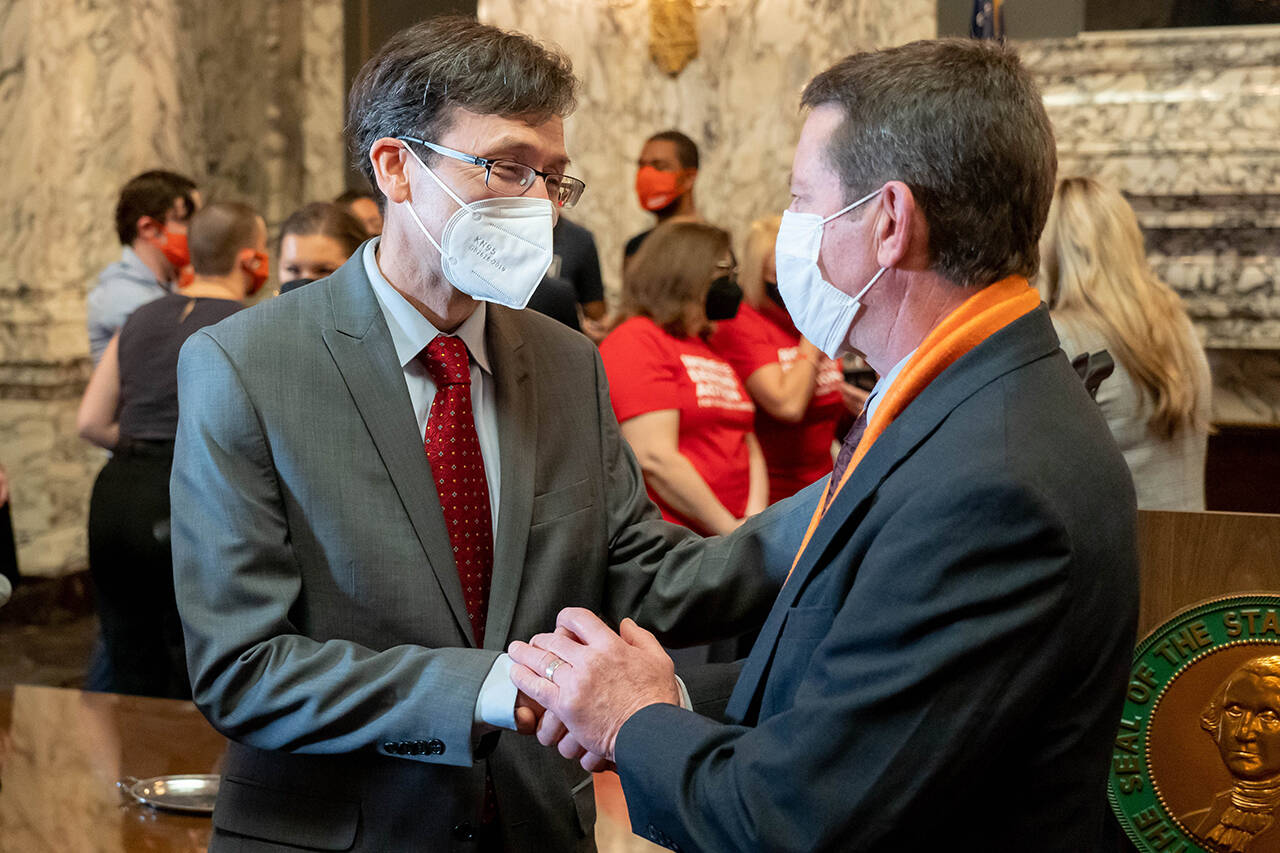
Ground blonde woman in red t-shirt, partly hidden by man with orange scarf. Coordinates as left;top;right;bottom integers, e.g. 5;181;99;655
708;216;860;501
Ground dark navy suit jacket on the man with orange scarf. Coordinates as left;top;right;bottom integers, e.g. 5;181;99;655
617;306;1138;853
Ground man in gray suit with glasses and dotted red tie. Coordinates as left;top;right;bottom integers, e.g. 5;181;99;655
172;18;796;850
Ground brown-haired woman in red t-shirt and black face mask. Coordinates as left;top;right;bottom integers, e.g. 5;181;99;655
600;222;768;534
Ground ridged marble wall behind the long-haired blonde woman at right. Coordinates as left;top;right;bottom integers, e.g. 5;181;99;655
1021;27;1280;424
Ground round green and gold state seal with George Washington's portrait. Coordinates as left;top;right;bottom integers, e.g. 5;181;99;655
1108;594;1280;853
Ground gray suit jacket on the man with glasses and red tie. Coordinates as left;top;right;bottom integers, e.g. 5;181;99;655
172;252;803;850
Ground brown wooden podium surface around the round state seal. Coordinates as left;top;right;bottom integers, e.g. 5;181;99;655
1106;507;1280;853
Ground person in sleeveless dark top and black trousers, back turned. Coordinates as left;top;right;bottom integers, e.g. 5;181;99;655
77;202;268;698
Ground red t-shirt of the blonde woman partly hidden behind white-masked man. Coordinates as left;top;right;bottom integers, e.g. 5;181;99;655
709;302;845;502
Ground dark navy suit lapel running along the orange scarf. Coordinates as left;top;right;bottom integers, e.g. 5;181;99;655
726;305;1059;720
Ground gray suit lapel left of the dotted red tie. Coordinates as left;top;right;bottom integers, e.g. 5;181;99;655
323;250;471;643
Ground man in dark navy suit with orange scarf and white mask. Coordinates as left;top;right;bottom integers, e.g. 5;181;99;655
511;41;1137;853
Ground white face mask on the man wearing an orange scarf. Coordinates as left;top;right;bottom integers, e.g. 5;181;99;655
774;190;888;359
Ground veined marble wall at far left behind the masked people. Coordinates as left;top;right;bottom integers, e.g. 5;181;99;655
0;0;344;575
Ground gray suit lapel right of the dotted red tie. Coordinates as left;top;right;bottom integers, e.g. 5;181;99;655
485;305;538;649
